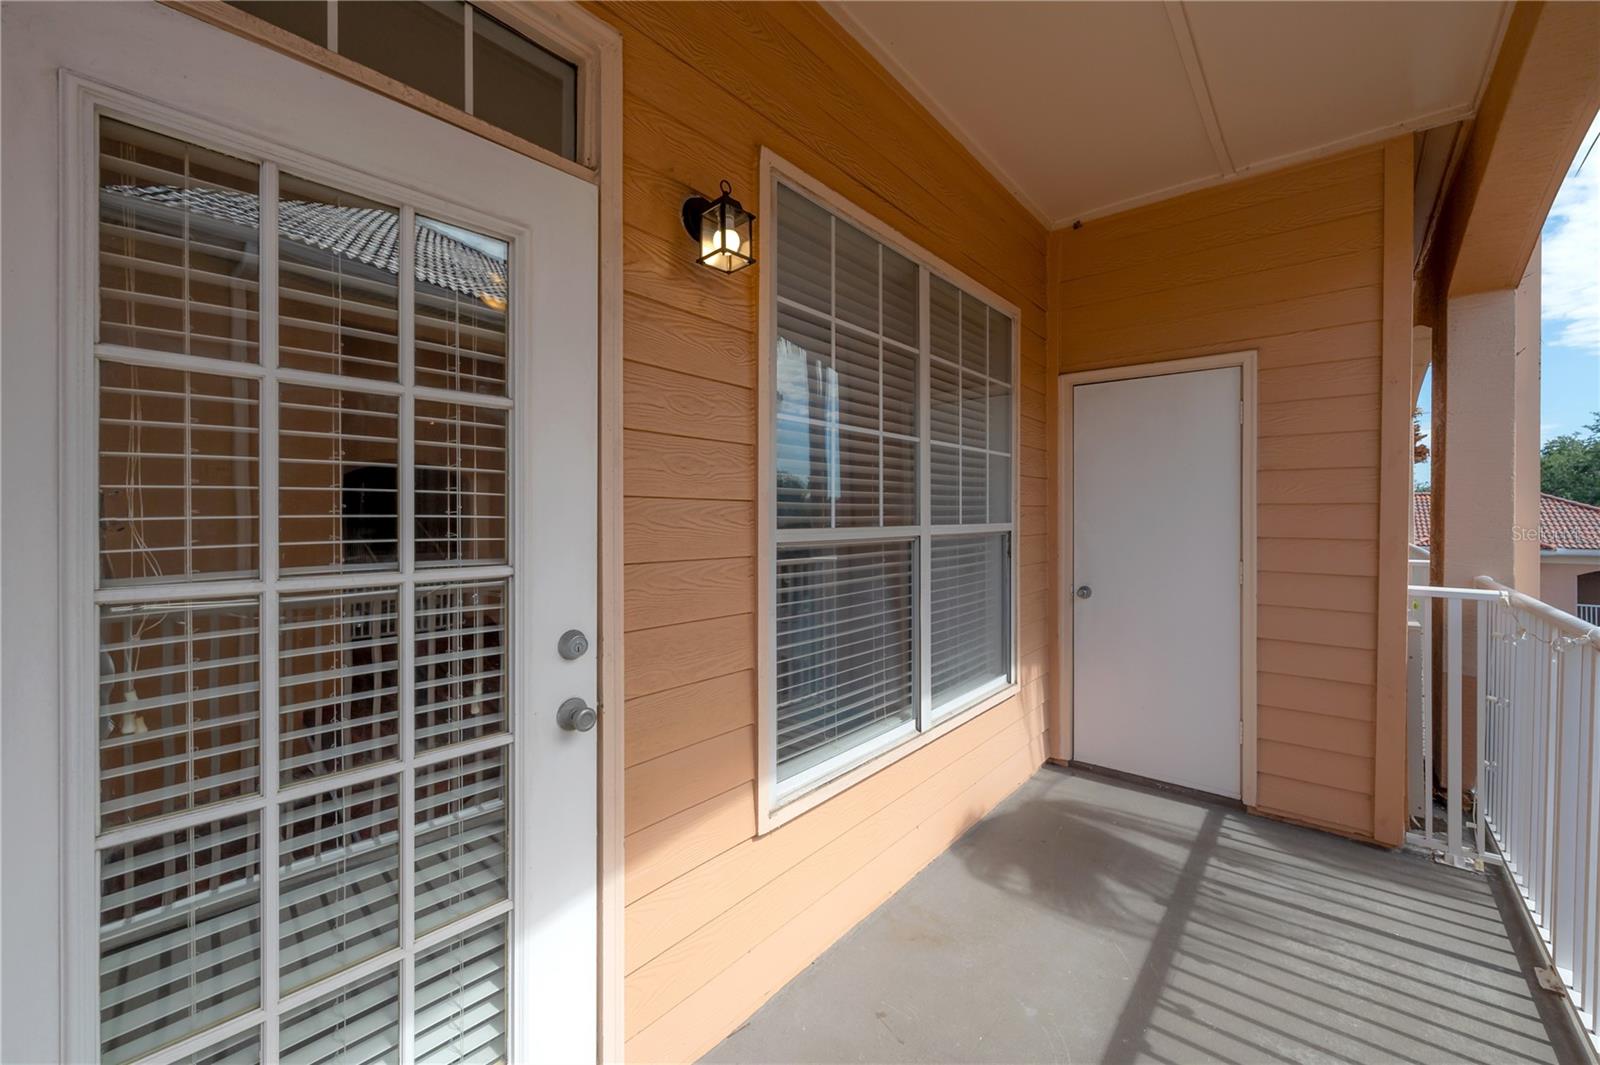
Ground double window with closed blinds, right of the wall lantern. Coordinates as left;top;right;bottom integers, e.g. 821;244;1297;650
766;179;1014;804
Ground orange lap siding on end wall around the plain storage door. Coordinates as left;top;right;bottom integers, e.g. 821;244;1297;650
1051;149;1384;836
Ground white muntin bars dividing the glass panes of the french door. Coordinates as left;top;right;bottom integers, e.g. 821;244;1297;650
87;110;518;1065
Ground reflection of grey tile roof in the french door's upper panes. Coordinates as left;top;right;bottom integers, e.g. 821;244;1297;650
101;185;506;307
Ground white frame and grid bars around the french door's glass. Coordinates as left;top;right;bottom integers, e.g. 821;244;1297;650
59;74;538;1065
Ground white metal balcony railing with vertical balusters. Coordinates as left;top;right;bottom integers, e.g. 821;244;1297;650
1410;577;1600;1038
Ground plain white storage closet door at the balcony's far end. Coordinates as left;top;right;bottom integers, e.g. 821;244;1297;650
1070;366;1243;798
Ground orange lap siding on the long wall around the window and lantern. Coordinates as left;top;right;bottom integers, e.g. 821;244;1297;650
592;3;1053;1062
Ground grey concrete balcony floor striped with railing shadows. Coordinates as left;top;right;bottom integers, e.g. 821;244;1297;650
704;768;1584;1065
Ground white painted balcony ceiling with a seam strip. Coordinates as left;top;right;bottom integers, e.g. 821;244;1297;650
829;0;1509;227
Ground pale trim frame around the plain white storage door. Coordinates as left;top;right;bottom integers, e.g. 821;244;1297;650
1050;350;1256;806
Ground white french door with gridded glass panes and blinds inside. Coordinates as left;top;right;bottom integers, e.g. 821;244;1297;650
6;5;597;1062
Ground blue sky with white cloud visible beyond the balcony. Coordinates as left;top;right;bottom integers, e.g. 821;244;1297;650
1416;115;1600;485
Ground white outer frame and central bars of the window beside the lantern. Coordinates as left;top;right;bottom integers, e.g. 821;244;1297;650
755;147;1022;835
